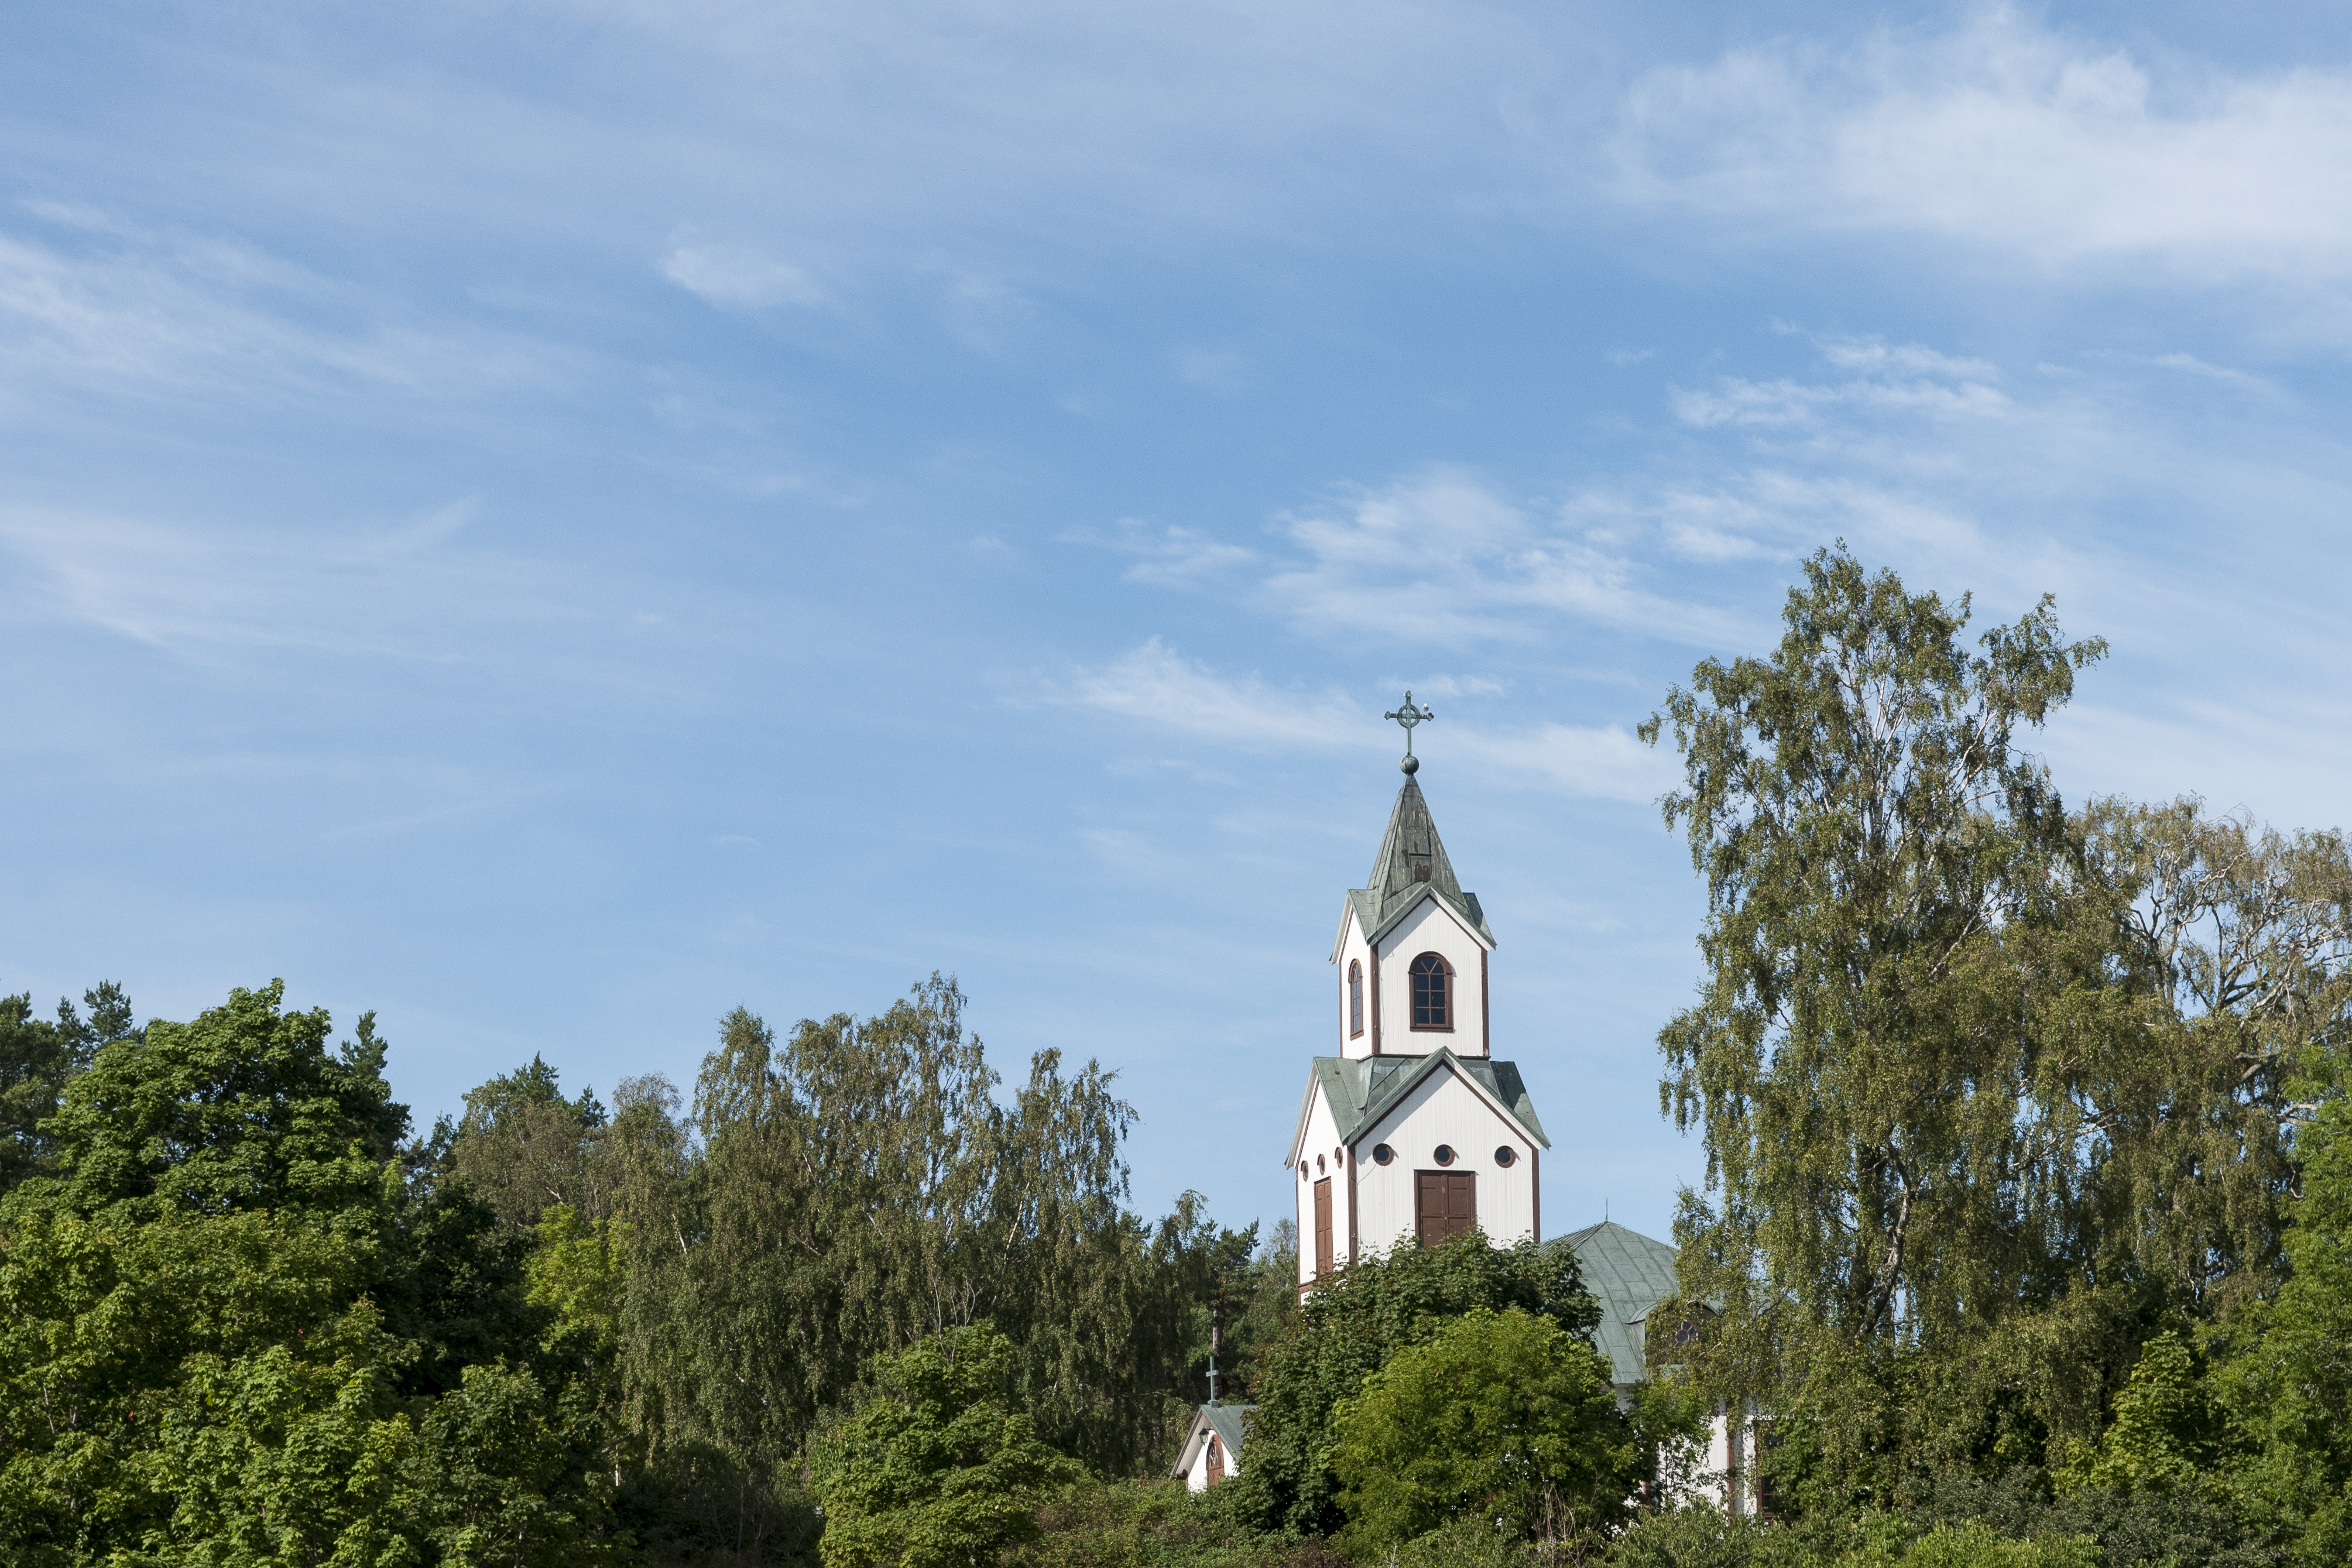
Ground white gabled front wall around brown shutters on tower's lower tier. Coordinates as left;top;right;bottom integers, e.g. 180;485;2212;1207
1355;1062;1543;1255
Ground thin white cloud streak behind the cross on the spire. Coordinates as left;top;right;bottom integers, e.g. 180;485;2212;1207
1047;637;1672;802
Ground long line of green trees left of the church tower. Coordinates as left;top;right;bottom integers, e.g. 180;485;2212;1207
0;978;1291;1563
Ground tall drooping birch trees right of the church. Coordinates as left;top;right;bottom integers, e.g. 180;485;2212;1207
1644;548;2352;1512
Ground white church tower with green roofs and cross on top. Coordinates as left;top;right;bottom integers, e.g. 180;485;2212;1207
1287;691;1550;1291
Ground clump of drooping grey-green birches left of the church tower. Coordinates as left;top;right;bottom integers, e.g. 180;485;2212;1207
607;978;1230;1495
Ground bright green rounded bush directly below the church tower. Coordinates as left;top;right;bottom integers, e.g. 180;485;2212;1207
1331;1307;1647;1554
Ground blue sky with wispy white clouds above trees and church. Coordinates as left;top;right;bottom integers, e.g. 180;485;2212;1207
0;0;2352;1234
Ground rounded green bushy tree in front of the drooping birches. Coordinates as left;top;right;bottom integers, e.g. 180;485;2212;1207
811;1323;1079;1568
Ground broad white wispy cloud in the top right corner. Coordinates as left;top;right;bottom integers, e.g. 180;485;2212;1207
1611;7;2352;282
